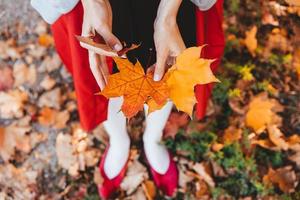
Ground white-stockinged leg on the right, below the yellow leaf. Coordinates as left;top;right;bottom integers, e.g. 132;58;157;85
143;101;173;174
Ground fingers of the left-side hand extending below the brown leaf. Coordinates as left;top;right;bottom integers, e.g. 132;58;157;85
89;51;105;90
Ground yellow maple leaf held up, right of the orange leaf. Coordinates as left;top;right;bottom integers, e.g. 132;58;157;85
166;46;220;116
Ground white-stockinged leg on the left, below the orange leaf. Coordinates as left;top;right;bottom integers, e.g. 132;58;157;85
103;97;130;179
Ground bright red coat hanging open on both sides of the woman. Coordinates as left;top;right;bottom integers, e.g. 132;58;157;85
51;0;225;131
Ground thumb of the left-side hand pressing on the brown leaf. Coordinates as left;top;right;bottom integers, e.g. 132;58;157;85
96;25;123;51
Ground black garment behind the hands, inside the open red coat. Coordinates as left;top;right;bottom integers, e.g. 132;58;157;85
110;0;196;69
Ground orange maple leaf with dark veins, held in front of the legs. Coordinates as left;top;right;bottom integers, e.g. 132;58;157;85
99;57;169;118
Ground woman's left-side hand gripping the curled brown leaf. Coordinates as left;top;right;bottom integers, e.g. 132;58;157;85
80;0;122;90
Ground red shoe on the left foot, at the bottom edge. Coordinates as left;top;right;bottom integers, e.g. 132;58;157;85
98;145;129;199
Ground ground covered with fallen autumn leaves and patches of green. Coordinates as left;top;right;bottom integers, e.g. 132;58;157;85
0;0;300;200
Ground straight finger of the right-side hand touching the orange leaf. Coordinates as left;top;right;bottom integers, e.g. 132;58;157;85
154;49;168;81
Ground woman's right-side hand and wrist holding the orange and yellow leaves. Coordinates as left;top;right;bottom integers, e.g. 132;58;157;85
154;0;188;81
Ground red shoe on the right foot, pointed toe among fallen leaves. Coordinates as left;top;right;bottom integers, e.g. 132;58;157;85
144;151;178;197
